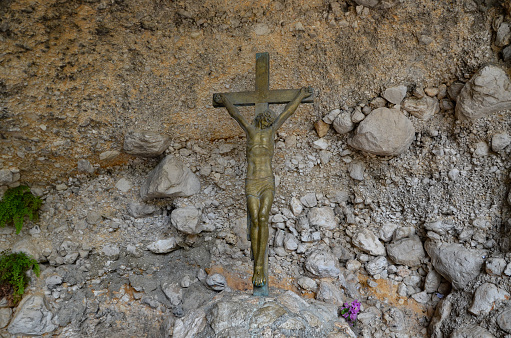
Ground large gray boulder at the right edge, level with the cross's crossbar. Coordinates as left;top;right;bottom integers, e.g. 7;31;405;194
456;65;511;120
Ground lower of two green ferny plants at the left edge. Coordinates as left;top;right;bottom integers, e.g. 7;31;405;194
0;251;40;304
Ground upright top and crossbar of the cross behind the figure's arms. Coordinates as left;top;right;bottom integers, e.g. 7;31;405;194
213;52;314;116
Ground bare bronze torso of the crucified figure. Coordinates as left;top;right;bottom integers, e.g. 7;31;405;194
247;126;275;179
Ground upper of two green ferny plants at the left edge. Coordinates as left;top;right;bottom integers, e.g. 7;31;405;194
0;185;43;234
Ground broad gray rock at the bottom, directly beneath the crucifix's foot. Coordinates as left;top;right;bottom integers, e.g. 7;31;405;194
169;291;355;338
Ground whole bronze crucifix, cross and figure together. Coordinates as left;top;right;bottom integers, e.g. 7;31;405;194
213;53;313;296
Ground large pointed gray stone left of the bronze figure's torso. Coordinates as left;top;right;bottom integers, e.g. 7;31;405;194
140;156;200;201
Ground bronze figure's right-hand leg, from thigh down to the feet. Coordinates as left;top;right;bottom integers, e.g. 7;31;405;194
252;190;273;286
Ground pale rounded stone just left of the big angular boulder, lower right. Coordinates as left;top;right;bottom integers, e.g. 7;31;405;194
387;236;426;267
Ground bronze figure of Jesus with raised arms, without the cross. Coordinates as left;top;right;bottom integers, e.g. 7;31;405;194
213;87;312;287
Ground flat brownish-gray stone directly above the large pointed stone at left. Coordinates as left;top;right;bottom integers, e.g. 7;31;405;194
123;131;171;157
